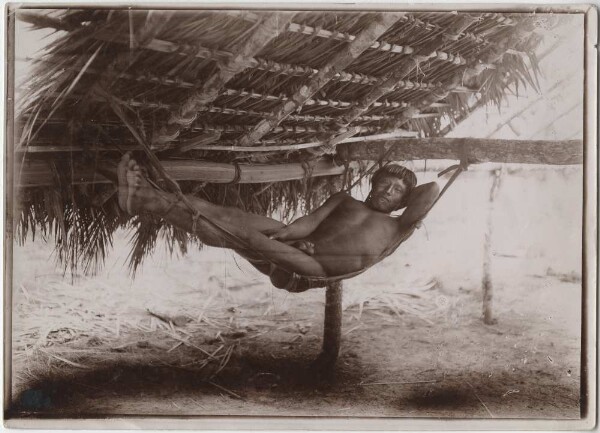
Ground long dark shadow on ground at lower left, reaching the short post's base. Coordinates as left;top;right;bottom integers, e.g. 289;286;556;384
7;353;368;418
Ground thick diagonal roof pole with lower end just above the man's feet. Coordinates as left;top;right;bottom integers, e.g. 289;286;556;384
151;12;292;147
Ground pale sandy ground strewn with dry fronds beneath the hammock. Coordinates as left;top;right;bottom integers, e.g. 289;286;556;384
7;169;582;419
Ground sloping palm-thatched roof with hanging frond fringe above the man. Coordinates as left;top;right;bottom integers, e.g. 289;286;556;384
15;9;540;270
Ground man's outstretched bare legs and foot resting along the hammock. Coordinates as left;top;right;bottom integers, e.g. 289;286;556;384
119;156;326;276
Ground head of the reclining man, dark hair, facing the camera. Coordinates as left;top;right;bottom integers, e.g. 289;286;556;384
367;164;417;213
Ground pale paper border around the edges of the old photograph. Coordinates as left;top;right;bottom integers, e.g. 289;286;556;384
3;2;598;430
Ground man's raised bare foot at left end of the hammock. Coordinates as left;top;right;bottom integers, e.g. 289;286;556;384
117;153;164;215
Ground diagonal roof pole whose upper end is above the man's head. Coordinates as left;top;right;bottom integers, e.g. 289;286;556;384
233;13;404;146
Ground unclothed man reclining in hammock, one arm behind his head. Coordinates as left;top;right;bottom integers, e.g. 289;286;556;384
118;154;439;292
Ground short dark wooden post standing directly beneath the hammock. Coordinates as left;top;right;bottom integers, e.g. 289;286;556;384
313;281;343;373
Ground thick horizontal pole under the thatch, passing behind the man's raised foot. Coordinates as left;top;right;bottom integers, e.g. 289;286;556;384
15;160;354;188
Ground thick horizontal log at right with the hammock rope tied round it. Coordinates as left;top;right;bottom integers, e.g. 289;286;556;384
338;137;583;165
